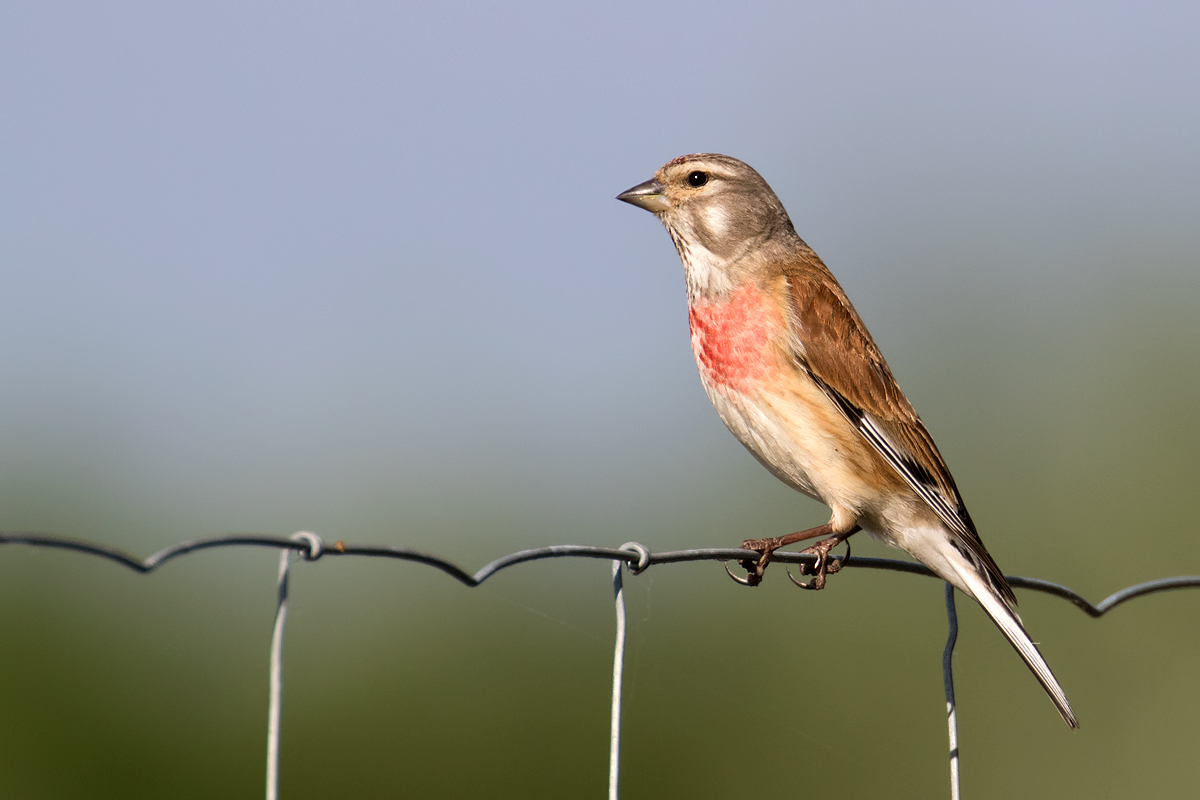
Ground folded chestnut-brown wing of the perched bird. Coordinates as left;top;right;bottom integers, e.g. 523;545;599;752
785;260;1016;604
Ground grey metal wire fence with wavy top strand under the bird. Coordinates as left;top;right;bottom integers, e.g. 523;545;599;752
0;531;1200;800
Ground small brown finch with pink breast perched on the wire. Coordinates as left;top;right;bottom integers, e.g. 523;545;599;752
617;152;1079;728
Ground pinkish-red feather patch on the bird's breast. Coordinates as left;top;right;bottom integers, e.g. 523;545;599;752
688;284;782;391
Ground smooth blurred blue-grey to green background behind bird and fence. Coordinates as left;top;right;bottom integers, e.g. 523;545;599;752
0;1;1200;798
